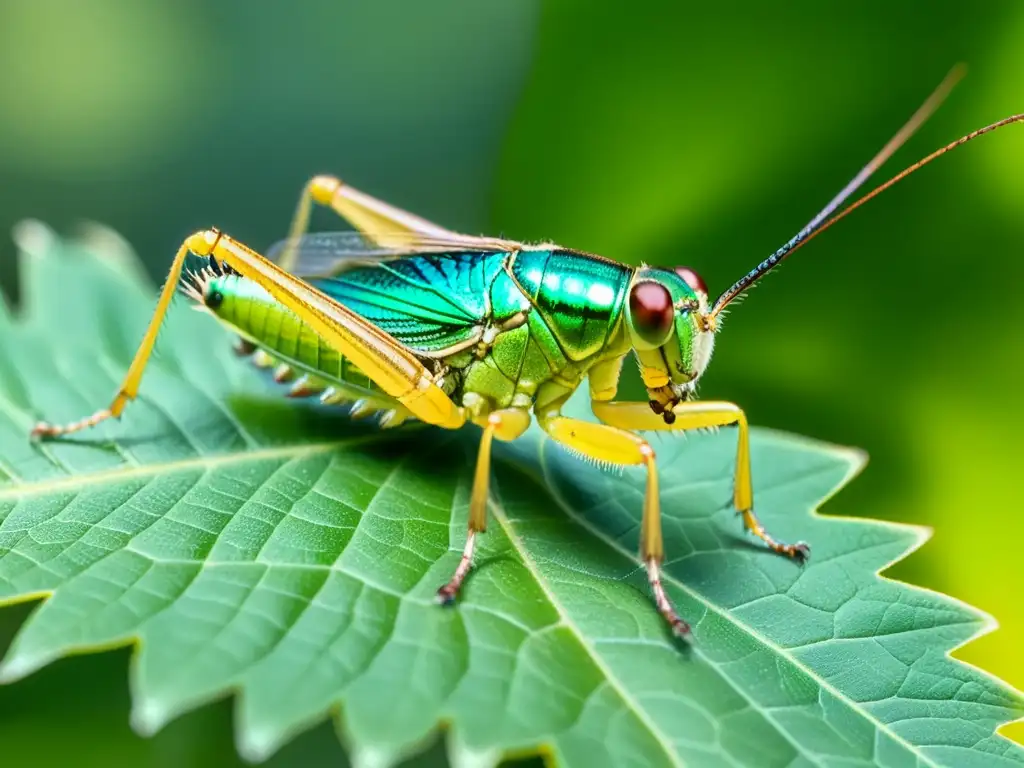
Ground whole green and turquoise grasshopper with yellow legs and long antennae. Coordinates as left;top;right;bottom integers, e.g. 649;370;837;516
33;75;1024;635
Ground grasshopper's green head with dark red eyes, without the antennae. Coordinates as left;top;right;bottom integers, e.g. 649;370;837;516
626;267;716;423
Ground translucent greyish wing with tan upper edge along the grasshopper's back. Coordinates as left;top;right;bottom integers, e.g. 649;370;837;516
267;231;524;278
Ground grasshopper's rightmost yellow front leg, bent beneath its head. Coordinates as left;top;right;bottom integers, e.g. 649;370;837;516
593;400;811;562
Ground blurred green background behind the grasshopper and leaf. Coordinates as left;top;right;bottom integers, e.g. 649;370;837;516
0;0;1024;766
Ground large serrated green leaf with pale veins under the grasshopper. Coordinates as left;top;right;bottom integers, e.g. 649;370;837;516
0;225;1024;767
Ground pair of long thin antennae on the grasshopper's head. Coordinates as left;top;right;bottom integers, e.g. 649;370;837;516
709;65;1024;319
